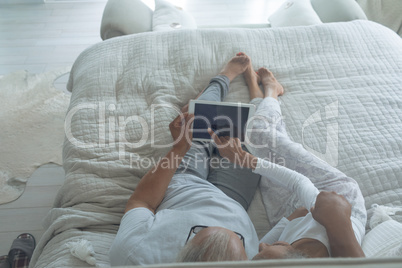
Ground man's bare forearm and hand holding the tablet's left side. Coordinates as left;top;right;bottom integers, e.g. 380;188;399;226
125;113;193;213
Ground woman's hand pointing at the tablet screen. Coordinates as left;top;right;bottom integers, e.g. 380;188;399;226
208;128;258;169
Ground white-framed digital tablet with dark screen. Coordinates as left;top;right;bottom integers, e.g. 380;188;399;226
188;100;255;142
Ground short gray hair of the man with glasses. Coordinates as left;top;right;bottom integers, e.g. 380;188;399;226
177;228;242;262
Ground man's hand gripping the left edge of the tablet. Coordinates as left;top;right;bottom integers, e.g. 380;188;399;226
169;113;194;153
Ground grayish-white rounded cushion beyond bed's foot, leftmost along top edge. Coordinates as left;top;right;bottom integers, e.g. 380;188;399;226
100;0;153;40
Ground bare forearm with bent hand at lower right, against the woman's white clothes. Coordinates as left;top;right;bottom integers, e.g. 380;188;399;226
311;192;365;257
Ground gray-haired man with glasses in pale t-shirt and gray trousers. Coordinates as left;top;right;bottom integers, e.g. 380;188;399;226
110;53;260;265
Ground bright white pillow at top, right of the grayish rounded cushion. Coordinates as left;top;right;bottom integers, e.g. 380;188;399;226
152;0;197;31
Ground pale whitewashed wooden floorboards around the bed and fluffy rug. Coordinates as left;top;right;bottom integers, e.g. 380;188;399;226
0;0;284;255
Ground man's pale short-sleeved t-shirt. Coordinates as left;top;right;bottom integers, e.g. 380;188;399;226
109;174;258;266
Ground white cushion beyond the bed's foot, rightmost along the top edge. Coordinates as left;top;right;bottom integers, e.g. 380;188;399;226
311;0;367;22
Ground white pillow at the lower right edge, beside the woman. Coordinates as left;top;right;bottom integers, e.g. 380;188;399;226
362;220;402;257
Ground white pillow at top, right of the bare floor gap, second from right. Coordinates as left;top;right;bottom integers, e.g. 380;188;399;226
268;0;322;27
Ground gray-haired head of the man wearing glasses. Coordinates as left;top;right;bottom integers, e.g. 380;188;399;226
177;227;248;262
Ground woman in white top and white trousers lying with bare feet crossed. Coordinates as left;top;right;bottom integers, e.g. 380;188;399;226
210;63;366;260
